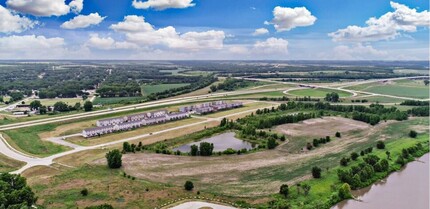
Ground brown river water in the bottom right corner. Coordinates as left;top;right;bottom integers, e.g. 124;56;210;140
332;153;430;209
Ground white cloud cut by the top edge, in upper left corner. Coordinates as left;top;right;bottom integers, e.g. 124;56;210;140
6;0;83;16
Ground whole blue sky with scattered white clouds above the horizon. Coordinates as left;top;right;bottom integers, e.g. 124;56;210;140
0;0;430;60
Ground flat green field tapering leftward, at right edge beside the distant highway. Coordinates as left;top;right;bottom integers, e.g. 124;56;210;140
346;80;429;99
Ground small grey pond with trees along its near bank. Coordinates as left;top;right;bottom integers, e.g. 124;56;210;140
173;132;253;152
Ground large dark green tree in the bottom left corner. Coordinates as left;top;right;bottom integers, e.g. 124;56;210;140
0;173;37;208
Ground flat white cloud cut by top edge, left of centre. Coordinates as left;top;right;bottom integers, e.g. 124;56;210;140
132;0;196;10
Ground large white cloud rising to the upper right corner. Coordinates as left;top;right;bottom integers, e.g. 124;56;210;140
328;2;430;42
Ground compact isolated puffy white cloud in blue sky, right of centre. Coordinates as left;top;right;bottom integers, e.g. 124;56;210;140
265;6;317;32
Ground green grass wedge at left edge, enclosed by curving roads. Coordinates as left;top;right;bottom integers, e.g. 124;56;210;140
4;124;69;157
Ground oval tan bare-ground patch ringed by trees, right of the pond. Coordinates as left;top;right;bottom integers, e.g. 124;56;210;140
275;117;371;137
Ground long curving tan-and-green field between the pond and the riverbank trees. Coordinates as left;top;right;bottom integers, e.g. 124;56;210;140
113;118;428;197
